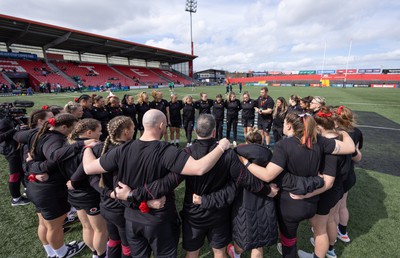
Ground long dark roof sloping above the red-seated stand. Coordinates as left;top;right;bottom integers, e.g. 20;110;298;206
0;14;197;64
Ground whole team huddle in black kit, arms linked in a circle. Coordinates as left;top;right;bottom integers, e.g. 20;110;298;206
0;87;363;258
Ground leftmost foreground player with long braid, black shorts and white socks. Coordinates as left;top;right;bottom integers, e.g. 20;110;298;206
27;113;93;257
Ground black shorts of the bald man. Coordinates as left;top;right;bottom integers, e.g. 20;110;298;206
125;216;180;258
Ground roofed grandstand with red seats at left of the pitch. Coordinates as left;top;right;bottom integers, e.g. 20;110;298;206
0;14;196;91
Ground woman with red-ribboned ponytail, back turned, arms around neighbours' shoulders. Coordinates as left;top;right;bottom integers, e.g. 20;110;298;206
242;113;354;257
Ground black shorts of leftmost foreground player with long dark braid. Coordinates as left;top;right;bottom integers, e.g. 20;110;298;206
26;182;71;220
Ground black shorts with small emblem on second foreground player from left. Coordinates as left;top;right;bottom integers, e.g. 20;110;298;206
68;190;100;216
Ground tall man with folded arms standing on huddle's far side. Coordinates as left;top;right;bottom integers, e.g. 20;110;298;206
256;87;275;147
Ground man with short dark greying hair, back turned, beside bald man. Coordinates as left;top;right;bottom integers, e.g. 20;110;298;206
180;114;269;257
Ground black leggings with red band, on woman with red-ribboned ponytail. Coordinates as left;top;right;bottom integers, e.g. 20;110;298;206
277;191;318;258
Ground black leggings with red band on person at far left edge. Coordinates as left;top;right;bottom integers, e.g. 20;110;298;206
6;155;24;198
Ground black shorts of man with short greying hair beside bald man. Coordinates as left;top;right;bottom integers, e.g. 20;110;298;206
182;220;232;252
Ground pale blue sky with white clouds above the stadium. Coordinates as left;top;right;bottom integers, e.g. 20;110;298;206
0;0;400;71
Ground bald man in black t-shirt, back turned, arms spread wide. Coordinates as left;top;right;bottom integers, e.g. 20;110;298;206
83;109;229;257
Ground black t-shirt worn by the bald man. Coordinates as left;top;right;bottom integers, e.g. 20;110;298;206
100;140;190;225
